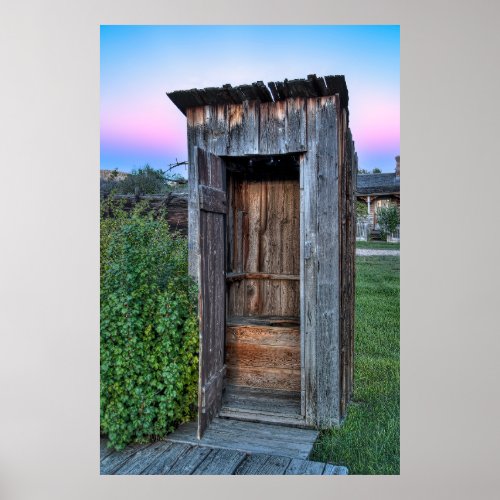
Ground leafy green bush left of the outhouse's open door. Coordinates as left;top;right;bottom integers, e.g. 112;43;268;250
100;200;198;449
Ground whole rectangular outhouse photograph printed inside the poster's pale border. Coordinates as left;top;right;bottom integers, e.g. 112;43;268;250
96;24;401;476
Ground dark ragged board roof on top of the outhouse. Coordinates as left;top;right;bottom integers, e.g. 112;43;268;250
167;75;349;115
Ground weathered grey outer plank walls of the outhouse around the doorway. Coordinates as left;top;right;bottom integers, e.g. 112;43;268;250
170;77;356;427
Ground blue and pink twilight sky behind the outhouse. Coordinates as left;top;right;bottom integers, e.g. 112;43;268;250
100;25;400;176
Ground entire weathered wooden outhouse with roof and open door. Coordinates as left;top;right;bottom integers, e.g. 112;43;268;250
168;75;356;437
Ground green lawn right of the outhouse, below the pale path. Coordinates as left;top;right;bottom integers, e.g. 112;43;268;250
311;257;399;474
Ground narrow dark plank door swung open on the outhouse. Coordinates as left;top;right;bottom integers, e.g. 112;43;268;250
196;148;227;438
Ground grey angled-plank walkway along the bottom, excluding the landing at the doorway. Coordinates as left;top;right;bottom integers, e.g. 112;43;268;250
101;439;348;475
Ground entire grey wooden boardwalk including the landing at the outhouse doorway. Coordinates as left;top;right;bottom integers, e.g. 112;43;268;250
101;418;348;475
